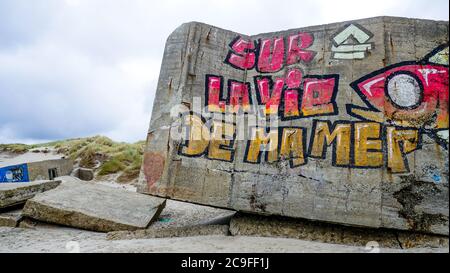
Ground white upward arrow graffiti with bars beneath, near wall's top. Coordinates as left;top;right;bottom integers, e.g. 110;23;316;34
331;23;374;60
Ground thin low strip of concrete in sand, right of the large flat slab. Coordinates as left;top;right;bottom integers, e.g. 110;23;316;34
107;225;229;240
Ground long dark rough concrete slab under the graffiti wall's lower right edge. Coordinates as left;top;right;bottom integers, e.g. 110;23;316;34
230;213;449;248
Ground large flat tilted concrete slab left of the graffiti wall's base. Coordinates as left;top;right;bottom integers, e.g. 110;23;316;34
23;181;166;232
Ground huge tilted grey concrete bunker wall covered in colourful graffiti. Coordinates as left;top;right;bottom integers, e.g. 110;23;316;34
139;17;449;234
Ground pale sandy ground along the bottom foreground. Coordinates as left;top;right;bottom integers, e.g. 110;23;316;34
0;225;449;253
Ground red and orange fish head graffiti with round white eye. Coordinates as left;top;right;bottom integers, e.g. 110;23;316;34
347;44;449;149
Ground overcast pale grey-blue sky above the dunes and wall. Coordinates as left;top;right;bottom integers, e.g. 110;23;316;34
0;0;449;143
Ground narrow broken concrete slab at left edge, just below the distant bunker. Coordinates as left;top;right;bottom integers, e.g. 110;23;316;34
0;180;61;209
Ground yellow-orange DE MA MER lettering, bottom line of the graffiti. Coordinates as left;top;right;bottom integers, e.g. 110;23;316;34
179;113;421;173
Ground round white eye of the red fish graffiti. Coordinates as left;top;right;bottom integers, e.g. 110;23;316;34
387;73;422;108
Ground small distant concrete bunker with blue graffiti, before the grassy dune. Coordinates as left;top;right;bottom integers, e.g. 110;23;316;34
0;153;73;183
